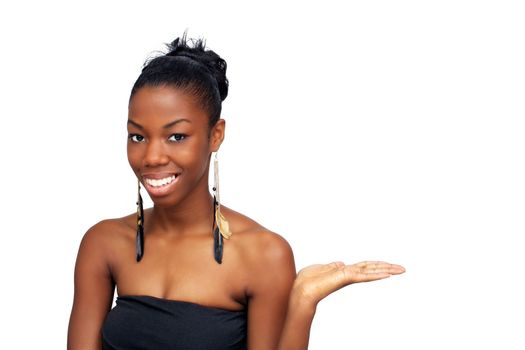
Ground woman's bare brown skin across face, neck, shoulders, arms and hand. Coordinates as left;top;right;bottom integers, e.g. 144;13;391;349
68;86;404;350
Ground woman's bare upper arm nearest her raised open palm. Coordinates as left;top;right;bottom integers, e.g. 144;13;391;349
248;232;296;350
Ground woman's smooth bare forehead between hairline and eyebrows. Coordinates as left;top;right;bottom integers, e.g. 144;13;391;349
128;86;208;128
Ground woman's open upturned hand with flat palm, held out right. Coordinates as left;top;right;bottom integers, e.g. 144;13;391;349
292;261;405;308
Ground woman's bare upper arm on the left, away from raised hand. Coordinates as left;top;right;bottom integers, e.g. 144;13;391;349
67;220;115;350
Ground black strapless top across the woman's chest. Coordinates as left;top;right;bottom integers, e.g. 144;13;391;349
102;295;247;350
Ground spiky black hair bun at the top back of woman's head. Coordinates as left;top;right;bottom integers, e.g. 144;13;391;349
166;31;228;101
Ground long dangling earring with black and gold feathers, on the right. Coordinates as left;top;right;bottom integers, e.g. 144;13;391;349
212;152;232;264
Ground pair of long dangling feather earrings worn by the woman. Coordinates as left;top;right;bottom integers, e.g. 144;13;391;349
136;152;232;264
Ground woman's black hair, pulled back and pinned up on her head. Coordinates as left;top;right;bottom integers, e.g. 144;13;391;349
129;30;228;127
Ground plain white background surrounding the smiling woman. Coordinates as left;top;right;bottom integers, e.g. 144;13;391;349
0;0;525;349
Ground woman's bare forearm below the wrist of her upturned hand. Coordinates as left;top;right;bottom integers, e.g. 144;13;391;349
278;294;316;350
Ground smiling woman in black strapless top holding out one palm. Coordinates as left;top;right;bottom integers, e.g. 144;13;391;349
68;33;404;350
